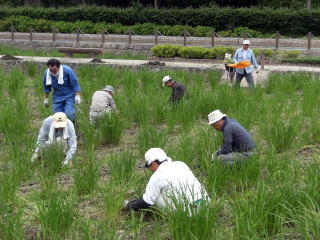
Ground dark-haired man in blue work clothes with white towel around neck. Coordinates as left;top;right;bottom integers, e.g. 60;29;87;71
43;58;81;121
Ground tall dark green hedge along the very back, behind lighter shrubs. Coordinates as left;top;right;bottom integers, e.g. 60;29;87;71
0;7;320;36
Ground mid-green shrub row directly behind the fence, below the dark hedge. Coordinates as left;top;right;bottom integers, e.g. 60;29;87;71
0;16;266;37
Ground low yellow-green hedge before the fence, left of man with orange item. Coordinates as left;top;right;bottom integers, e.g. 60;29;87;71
151;44;235;59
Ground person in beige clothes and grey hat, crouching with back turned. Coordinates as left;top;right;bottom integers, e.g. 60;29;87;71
89;85;116;122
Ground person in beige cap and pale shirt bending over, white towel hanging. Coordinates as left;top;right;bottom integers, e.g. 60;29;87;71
31;112;77;165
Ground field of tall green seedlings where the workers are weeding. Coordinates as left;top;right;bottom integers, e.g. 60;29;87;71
0;63;320;240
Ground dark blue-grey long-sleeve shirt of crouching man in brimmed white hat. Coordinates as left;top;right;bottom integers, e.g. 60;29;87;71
217;118;255;155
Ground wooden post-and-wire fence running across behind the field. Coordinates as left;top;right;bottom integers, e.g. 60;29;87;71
0;27;320;50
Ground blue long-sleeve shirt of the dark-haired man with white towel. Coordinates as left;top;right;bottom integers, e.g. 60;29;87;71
43;65;80;103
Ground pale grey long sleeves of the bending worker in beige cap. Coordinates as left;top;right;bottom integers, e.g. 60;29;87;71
35;116;77;161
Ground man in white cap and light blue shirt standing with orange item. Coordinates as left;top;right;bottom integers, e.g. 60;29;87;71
233;40;258;87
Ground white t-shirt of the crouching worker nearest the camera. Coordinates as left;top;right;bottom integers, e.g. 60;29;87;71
143;161;209;207
